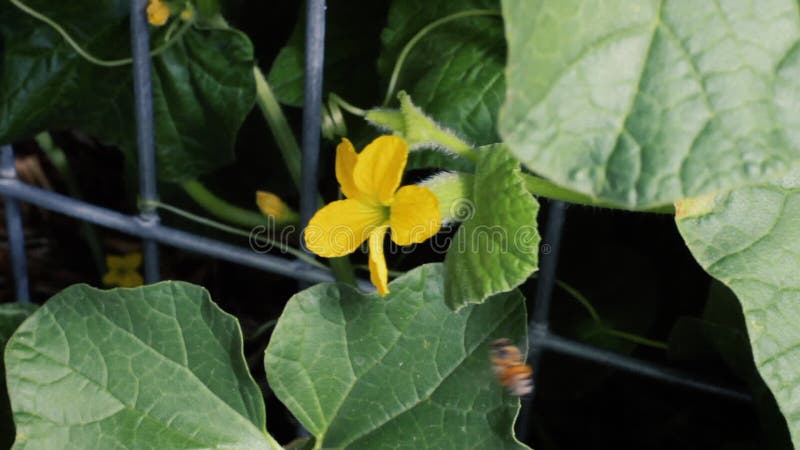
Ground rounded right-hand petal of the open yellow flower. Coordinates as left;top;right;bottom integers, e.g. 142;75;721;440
390;185;442;245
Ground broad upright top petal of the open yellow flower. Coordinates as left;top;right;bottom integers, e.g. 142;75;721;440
353;136;408;205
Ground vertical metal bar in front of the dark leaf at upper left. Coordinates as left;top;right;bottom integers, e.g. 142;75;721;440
131;0;160;283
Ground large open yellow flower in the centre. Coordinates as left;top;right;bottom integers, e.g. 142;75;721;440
304;136;441;295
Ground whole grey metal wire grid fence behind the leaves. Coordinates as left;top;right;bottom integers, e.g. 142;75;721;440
0;0;751;440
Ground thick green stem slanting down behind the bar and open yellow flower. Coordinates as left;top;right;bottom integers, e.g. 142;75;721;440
253;67;356;286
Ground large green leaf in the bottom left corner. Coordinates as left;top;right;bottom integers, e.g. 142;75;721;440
5;282;279;450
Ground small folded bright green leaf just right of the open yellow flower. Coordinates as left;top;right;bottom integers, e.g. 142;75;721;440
445;145;539;309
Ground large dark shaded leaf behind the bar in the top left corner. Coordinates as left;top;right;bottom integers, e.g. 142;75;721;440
0;0;255;181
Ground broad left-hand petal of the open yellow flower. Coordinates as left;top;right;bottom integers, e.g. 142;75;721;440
303;199;389;258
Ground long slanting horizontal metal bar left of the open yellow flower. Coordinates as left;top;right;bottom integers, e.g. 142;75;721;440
0;179;340;286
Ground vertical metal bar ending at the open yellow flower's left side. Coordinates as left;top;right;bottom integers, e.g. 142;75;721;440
300;0;325;228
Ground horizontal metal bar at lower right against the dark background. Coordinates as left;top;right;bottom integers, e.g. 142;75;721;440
536;333;752;402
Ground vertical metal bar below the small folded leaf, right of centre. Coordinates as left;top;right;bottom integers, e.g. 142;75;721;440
516;201;567;442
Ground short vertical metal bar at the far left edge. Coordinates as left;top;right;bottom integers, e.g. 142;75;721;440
0;145;31;303
